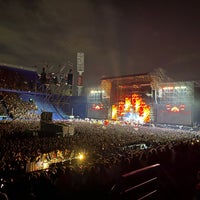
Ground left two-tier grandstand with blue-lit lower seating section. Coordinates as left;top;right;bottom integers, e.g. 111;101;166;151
0;64;87;120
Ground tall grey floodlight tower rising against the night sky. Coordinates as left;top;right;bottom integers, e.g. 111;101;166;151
77;52;84;96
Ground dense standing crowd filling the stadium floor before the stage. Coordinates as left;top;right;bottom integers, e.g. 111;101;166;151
0;120;200;200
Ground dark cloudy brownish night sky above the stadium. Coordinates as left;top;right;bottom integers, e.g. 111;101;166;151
0;0;200;86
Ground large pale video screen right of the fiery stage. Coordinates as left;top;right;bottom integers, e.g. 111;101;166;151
156;81;194;125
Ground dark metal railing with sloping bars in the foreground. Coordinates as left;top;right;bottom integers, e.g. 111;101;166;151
111;164;160;200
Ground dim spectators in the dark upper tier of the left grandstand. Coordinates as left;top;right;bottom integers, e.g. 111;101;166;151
0;65;73;95
